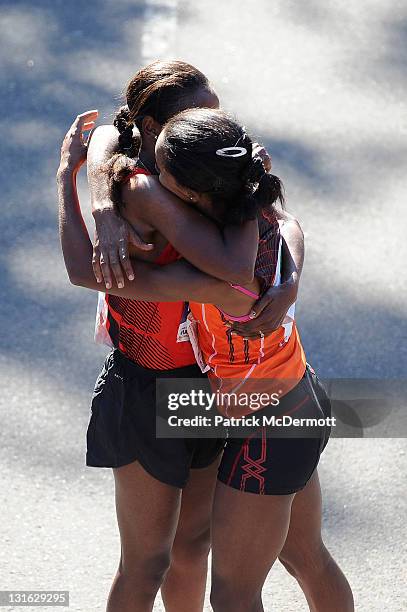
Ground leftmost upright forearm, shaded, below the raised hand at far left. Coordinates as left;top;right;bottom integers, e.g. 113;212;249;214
57;168;98;288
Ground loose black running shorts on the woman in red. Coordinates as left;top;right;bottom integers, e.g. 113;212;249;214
86;349;225;488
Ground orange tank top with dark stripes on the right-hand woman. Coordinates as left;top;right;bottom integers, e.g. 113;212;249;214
190;214;306;417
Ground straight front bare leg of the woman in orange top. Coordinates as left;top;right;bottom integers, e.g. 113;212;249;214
211;482;294;612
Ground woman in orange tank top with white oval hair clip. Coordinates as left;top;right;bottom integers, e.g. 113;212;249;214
59;109;353;612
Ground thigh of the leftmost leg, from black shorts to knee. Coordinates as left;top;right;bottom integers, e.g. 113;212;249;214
113;461;181;571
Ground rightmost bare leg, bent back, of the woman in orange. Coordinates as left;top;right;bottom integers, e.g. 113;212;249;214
279;471;354;612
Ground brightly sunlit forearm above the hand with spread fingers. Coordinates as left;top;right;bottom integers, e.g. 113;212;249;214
87;125;119;215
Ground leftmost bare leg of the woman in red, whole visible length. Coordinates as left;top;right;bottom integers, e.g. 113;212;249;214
106;461;181;612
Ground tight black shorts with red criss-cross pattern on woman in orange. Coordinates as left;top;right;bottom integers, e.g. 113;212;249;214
218;364;331;495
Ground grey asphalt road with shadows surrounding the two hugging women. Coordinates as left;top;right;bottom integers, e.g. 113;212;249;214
0;0;407;612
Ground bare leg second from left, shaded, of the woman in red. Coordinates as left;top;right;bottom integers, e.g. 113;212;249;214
161;457;220;612
